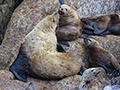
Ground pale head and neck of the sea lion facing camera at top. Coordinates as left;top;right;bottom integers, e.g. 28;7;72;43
58;4;80;25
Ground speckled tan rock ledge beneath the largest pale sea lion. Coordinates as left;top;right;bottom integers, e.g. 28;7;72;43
0;70;81;90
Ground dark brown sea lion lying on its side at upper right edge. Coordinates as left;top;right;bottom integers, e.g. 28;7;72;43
81;13;120;36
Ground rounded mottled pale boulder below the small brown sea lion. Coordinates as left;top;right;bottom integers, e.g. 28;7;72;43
78;67;108;90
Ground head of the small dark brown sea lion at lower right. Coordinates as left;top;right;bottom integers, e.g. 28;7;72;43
84;38;99;48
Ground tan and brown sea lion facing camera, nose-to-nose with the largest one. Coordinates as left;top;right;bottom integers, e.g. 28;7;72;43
56;4;83;41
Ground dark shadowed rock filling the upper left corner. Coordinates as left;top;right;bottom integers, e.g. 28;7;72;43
0;0;22;44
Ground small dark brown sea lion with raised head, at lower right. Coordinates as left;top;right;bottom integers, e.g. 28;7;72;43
84;38;120;73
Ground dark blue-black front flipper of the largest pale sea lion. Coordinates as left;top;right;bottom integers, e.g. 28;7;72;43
9;54;27;82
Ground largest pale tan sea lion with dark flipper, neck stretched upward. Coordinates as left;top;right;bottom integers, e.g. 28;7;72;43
9;13;82;82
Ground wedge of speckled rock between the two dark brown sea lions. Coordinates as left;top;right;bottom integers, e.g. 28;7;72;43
94;35;120;57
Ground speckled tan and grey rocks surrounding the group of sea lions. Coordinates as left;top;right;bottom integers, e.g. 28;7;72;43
0;0;120;90
